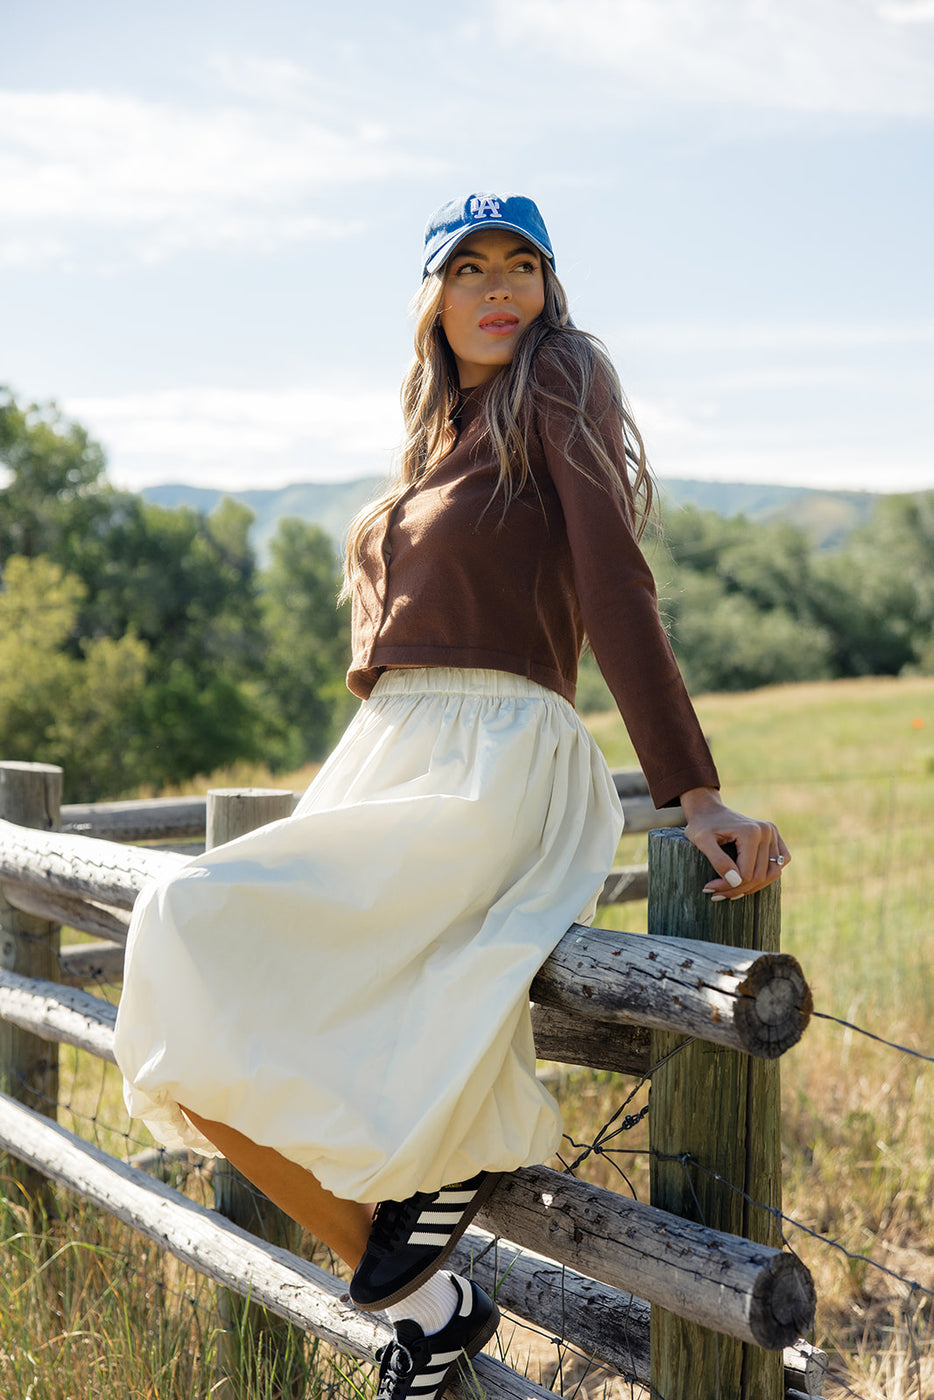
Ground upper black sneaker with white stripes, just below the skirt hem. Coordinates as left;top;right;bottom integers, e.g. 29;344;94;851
350;1172;503;1312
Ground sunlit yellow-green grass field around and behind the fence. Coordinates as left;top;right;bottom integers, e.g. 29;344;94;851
0;678;934;1400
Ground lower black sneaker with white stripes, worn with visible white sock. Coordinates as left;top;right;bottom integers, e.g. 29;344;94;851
377;1274;500;1400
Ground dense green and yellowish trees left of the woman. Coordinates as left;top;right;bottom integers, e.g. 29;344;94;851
0;389;356;801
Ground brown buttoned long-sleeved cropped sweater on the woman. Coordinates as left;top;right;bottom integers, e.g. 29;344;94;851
347;358;718;806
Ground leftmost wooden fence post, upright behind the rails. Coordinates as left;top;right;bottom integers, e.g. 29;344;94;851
0;763;62;1214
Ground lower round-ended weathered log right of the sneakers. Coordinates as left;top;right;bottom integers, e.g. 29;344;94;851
478;1166;814;1348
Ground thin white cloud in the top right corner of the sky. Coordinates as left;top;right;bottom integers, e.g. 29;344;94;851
494;0;934;118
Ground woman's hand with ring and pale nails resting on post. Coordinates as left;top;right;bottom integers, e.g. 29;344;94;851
681;788;791;902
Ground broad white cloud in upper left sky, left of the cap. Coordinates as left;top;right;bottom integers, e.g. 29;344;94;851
0;92;437;262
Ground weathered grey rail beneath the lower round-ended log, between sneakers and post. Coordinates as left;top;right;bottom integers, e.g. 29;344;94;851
451;1229;650;1380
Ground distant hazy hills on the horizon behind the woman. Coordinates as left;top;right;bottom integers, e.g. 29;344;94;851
143;476;879;563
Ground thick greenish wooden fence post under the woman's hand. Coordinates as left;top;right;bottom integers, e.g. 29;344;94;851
648;830;783;1400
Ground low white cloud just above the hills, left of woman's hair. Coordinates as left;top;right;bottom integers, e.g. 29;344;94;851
63;384;402;490
